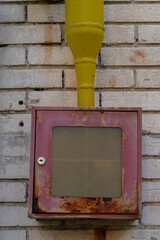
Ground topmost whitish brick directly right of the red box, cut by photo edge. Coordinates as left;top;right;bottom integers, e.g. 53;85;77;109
142;113;160;133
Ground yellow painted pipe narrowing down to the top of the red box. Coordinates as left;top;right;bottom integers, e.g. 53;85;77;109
65;0;104;107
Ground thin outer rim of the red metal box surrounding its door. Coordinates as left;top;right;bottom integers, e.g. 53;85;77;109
28;107;142;220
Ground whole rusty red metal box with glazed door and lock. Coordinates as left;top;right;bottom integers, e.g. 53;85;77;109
29;107;142;219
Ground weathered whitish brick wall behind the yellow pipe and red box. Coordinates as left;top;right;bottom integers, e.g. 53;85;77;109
0;0;160;240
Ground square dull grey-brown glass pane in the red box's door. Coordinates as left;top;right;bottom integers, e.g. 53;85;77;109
51;127;122;198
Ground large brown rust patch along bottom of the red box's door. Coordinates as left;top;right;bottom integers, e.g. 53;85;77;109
59;181;137;213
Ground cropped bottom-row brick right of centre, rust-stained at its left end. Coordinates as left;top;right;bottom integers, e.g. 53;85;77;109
106;229;160;240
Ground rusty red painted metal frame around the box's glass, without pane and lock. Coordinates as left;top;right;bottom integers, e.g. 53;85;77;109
29;107;142;219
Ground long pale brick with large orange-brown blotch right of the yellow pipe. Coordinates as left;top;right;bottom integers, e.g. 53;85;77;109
101;47;160;66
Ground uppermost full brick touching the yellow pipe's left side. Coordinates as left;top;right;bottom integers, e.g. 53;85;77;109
28;4;65;23
